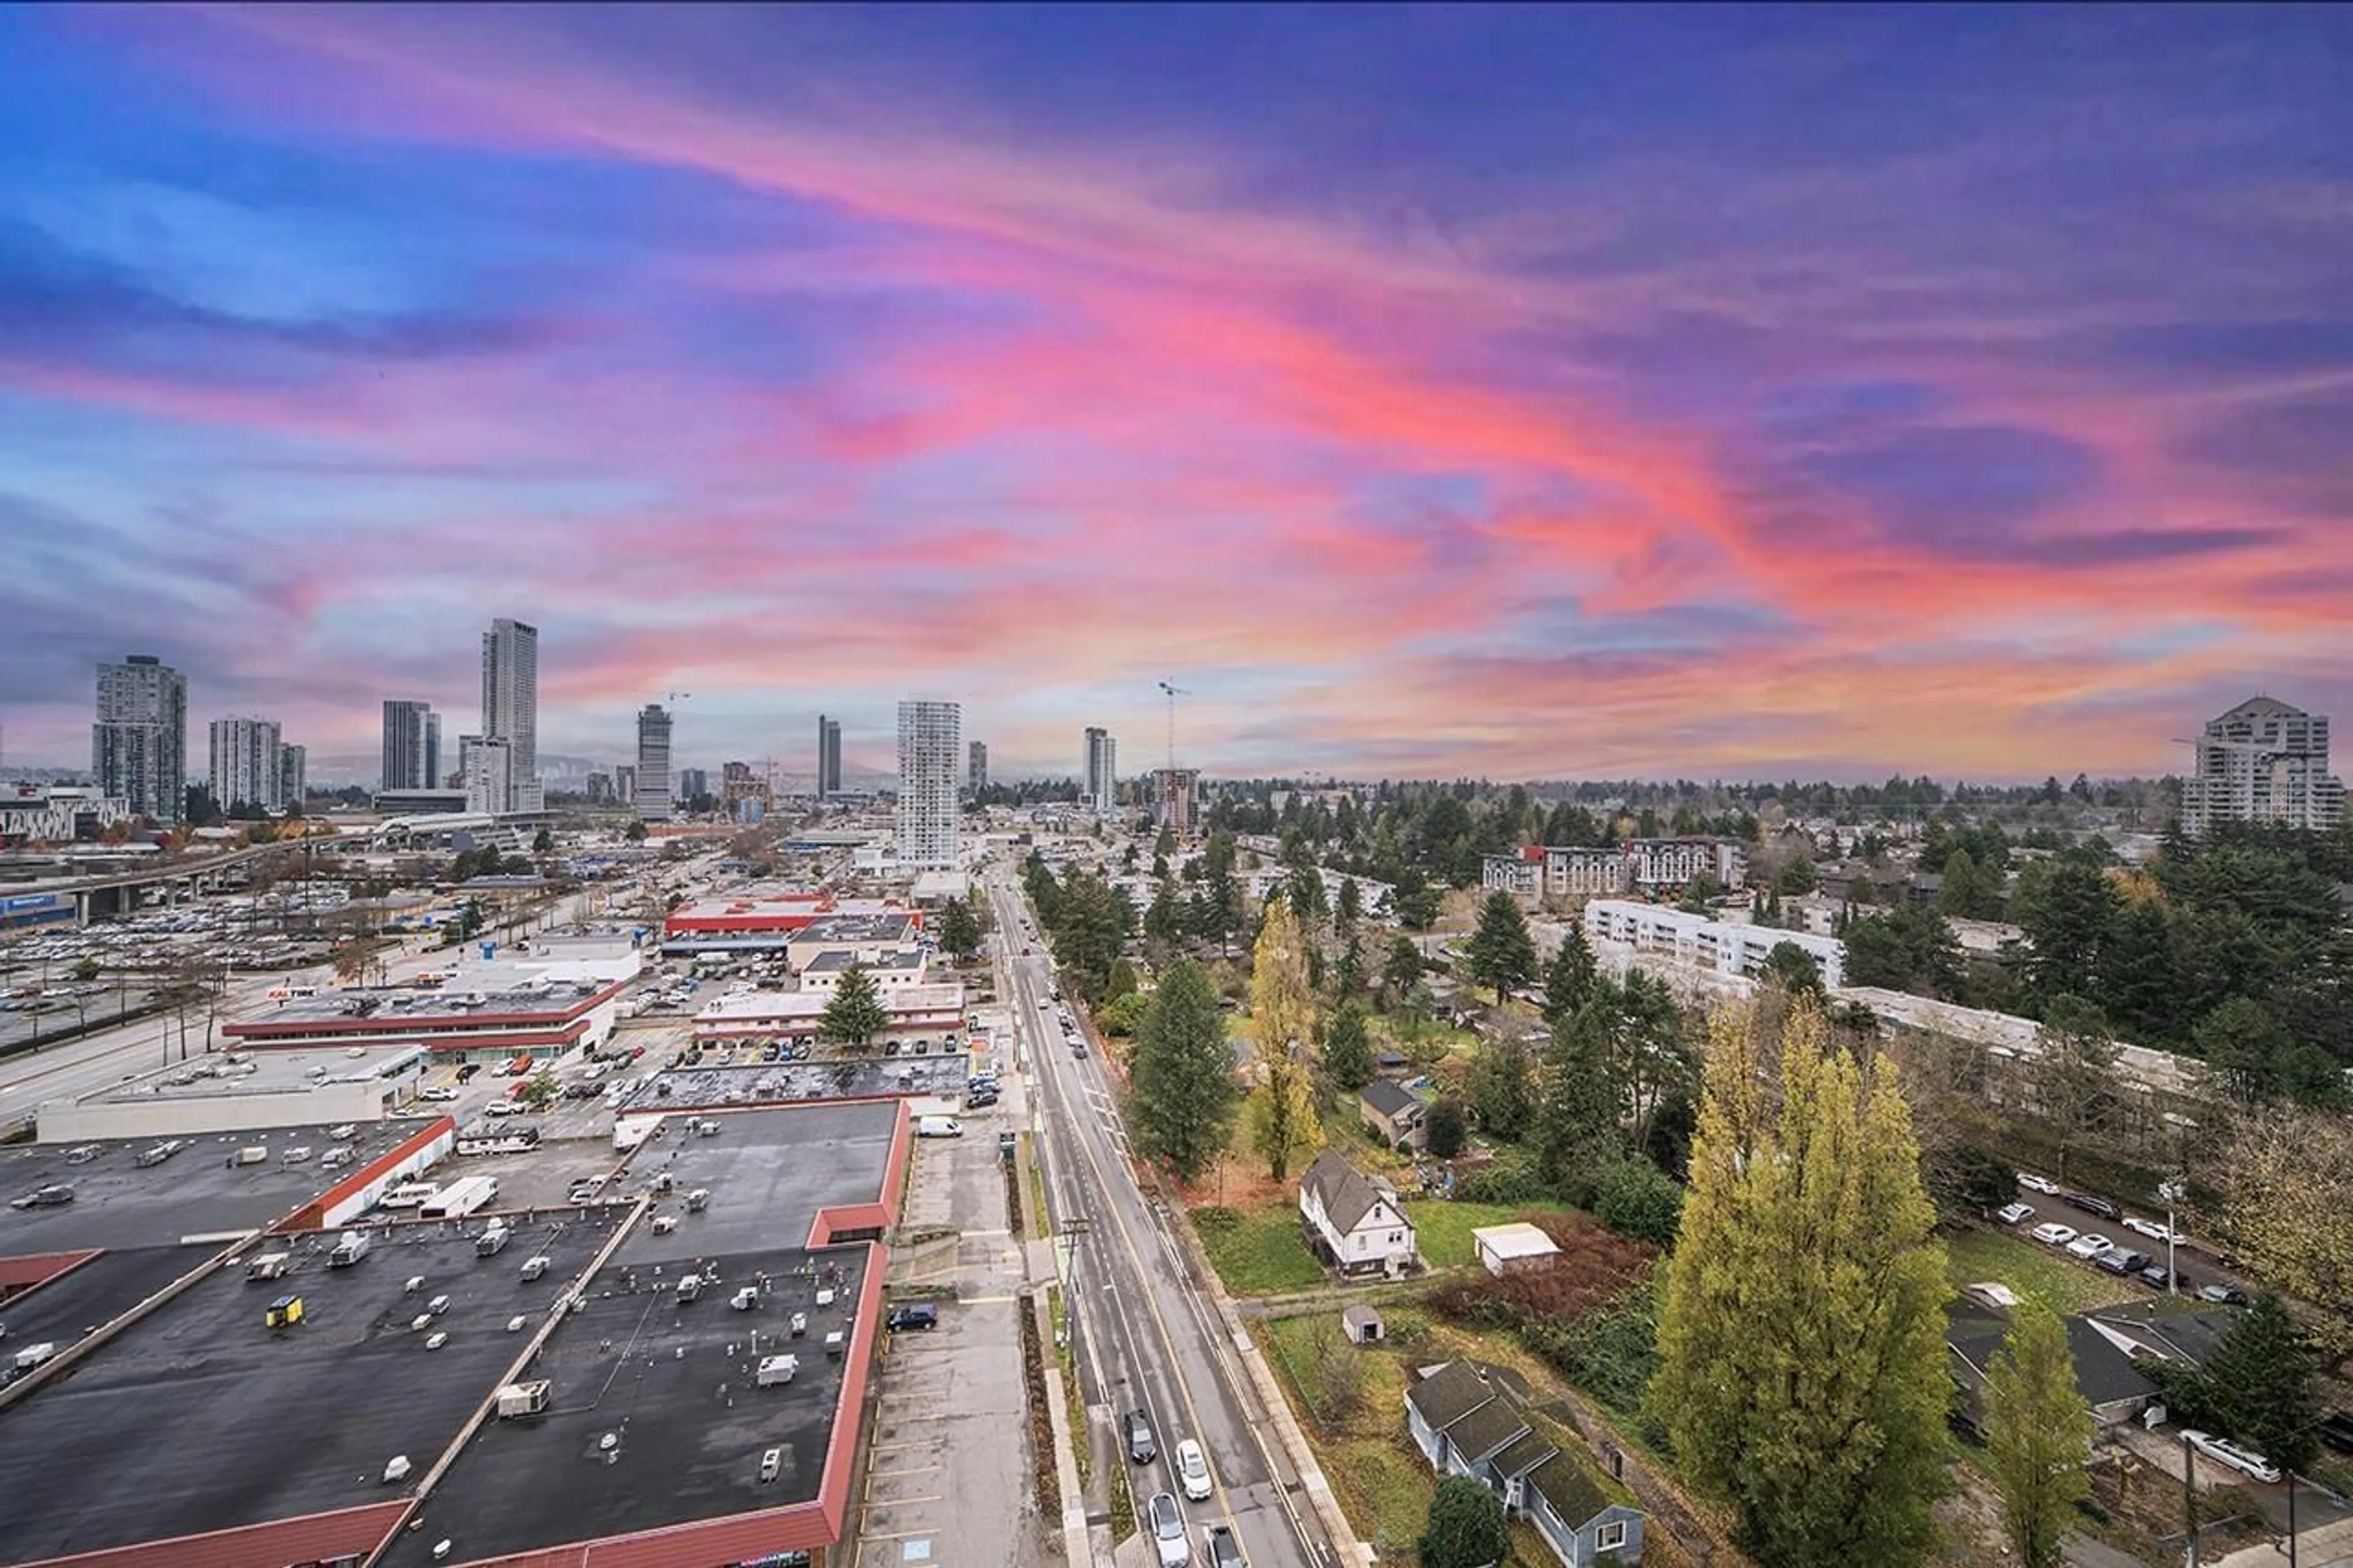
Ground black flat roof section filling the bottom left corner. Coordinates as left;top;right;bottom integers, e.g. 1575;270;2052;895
0;1210;626;1561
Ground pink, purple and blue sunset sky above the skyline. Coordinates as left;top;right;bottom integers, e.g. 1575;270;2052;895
0;7;2353;779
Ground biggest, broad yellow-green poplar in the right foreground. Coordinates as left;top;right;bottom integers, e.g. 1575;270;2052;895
1650;1001;1950;1568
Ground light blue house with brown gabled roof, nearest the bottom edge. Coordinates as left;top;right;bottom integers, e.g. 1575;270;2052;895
1404;1361;1642;1568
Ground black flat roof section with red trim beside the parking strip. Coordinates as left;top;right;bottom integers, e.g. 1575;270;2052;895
384;1104;899;1568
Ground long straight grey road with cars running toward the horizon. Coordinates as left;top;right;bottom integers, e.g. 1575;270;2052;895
988;878;1334;1568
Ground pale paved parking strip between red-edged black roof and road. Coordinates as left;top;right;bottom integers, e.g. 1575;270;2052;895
854;1088;1047;1568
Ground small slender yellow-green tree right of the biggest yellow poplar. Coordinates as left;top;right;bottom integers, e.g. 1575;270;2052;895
1981;1297;2092;1568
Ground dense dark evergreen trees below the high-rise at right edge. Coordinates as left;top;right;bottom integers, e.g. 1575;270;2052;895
1843;827;2353;1104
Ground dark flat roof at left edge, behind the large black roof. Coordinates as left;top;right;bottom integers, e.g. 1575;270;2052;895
0;1118;431;1264
